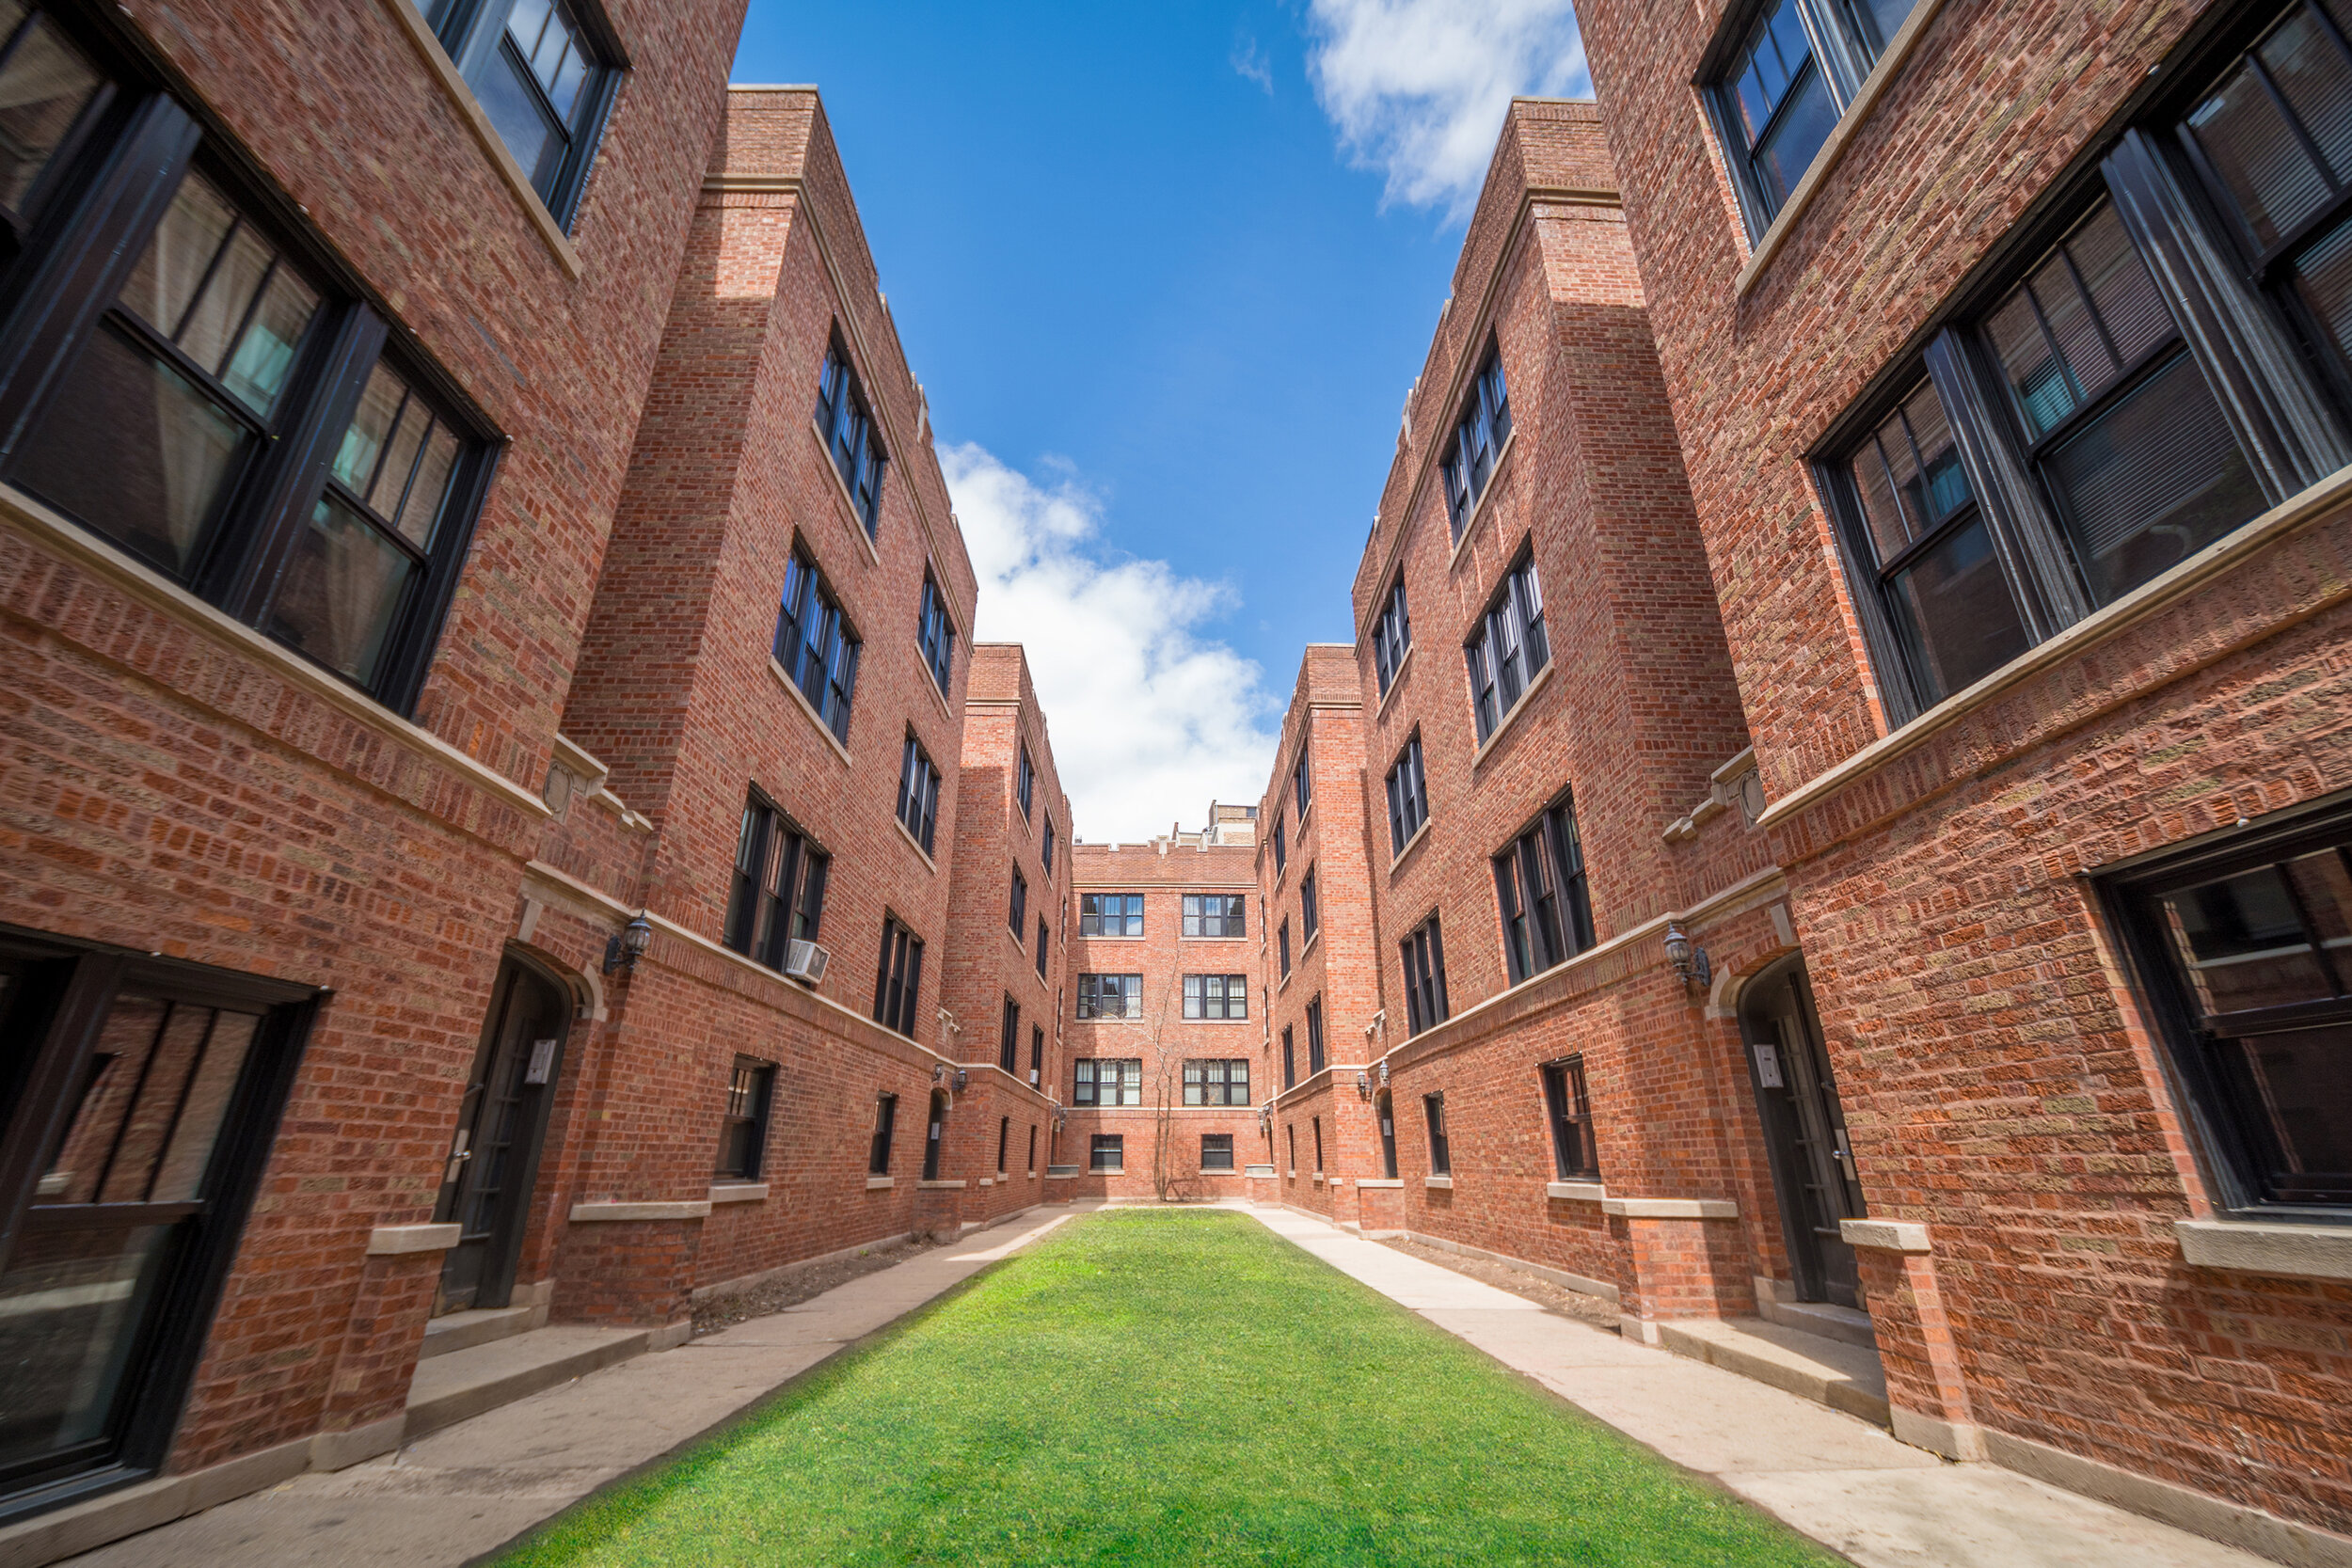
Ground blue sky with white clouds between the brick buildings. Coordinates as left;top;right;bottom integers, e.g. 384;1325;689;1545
734;0;1588;839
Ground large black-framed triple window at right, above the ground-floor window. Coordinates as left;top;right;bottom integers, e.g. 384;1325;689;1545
1816;2;2352;724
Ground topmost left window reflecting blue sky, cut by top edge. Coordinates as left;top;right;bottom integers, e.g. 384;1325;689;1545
426;0;621;228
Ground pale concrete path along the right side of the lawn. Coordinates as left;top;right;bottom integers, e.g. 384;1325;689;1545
1232;1204;2275;1568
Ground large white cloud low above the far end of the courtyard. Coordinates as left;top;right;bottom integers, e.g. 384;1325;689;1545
939;444;1278;844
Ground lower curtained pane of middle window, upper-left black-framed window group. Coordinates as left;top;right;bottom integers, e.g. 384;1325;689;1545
17;329;247;576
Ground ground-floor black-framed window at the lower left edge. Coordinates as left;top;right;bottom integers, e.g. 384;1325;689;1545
0;926;315;1516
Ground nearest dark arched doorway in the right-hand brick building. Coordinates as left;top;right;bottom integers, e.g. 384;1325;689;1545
1740;957;1863;1307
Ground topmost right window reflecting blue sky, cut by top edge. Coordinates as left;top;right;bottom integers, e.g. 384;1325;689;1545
1708;0;1915;240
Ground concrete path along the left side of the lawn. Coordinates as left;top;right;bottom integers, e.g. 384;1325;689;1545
69;1209;1082;1568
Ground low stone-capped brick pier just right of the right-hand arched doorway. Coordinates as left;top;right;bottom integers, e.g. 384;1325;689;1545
1842;1220;1985;1460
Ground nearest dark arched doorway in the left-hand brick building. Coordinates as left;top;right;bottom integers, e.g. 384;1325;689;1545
433;957;572;1317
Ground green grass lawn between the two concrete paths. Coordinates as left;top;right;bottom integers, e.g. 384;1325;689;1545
503;1211;1839;1568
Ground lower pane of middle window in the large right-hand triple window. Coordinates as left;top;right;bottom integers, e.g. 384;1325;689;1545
2044;355;2265;604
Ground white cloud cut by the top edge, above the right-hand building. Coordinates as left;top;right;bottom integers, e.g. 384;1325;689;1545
1308;0;1593;218
